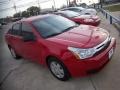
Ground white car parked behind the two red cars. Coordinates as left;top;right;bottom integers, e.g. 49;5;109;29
62;7;97;15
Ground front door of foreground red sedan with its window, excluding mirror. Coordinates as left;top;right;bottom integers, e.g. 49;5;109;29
20;22;42;61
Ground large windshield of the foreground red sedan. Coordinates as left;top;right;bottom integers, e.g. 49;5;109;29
33;15;76;38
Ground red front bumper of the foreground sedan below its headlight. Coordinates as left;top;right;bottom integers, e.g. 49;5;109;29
64;38;116;77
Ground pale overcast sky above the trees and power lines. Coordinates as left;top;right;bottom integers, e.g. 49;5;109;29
0;0;98;18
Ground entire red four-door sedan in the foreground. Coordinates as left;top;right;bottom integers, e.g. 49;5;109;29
5;14;116;81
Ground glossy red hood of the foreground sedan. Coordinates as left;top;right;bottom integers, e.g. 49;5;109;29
47;25;109;48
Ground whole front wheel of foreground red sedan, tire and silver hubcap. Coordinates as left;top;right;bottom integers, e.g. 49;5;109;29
48;58;70;81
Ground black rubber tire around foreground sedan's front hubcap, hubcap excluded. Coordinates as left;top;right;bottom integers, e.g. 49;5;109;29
47;58;71;81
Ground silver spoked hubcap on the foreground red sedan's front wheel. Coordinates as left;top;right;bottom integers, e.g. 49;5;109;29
50;61;64;78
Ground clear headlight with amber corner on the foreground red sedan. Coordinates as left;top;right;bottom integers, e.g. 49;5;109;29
68;47;95;59
